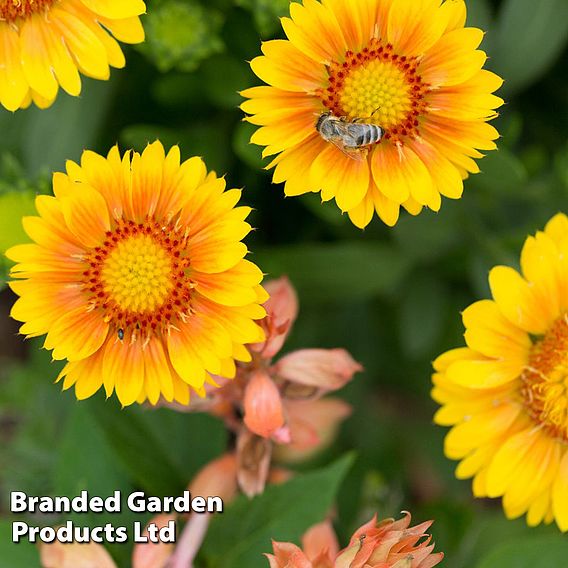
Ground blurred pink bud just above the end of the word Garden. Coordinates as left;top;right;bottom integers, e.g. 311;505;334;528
189;454;237;503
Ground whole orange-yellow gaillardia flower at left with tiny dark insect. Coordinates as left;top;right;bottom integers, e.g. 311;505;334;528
6;142;267;405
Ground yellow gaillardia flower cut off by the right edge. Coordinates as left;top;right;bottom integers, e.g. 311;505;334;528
433;214;568;531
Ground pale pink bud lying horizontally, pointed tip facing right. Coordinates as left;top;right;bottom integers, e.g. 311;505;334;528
274;349;363;392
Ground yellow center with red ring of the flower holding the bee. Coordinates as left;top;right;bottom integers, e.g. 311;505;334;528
318;39;427;141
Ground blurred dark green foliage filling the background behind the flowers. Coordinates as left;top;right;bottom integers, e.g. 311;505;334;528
0;0;568;568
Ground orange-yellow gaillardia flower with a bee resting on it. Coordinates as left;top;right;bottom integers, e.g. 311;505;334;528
241;0;503;228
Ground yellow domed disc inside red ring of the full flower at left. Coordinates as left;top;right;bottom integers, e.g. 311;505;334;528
102;235;173;313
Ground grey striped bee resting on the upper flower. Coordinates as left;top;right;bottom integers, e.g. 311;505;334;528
316;112;383;160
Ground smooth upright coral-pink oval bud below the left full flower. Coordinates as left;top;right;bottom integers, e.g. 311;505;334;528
244;371;284;438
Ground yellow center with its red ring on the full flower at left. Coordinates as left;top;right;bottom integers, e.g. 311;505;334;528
83;218;194;342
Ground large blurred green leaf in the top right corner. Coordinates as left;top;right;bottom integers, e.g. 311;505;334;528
492;0;568;96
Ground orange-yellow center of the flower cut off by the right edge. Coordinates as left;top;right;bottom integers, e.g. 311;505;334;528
521;316;568;442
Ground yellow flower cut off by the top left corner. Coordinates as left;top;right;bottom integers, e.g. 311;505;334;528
0;0;146;111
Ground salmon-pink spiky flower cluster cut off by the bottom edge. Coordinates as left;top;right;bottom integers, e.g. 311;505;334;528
266;513;444;568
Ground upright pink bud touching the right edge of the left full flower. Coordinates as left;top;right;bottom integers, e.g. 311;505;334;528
252;276;298;359
